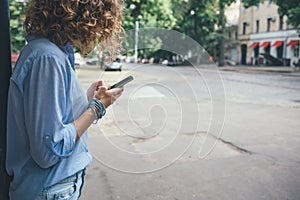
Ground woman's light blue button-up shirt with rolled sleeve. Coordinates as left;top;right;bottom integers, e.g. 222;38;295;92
6;36;92;200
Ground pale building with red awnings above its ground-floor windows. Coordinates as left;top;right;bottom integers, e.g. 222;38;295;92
238;0;300;66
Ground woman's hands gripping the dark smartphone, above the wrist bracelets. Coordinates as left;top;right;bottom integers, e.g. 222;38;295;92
94;81;124;108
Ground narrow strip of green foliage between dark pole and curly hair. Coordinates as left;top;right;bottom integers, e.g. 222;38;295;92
9;0;26;52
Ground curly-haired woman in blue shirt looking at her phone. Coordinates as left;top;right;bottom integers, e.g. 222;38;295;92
6;0;123;200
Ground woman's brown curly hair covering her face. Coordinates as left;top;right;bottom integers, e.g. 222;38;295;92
24;0;124;56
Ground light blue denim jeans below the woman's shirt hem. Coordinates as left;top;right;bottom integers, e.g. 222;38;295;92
35;170;85;200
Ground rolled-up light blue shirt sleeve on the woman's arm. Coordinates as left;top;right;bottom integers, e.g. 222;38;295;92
24;55;76;168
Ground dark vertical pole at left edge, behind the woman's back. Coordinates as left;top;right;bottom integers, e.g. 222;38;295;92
0;0;11;200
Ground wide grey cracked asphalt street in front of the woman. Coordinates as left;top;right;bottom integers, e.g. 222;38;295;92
77;64;300;200
